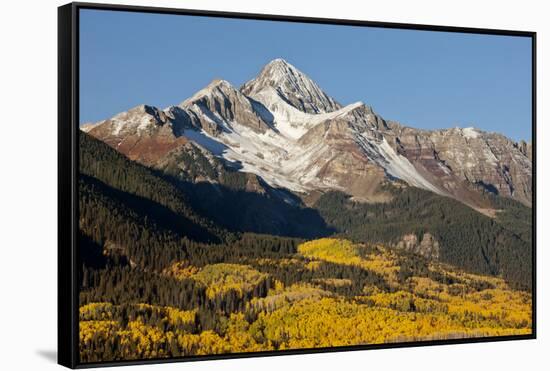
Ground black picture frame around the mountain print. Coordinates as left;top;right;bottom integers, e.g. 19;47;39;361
57;2;537;368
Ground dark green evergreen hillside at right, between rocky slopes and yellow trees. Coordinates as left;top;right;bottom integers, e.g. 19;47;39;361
315;187;531;288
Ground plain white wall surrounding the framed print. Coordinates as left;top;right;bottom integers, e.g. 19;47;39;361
0;0;550;371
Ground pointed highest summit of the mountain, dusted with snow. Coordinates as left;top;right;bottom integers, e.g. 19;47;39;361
241;58;342;114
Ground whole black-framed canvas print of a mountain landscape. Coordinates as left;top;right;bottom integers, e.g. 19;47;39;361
58;3;536;368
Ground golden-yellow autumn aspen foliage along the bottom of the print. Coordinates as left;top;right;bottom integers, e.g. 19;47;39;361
80;239;532;361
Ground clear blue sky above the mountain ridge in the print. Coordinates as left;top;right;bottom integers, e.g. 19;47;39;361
80;10;531;140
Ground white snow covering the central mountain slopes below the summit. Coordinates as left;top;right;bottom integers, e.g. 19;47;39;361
168;72;422;198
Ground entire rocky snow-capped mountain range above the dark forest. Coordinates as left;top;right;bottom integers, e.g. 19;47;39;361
83;59;532;209
